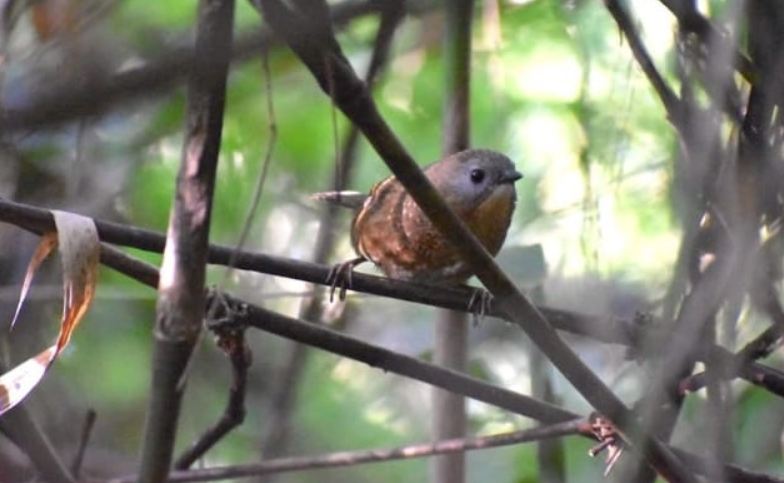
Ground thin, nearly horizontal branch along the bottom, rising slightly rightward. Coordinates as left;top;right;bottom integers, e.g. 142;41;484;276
111;419;590;483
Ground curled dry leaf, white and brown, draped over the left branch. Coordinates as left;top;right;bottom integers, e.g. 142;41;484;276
0;211;100;414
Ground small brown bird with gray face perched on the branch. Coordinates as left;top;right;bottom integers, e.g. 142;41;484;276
316;149;523;298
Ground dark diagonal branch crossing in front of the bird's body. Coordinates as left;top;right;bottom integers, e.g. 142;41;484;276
257;0;696;482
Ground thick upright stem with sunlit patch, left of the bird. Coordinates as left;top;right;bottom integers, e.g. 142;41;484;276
139;0;234;482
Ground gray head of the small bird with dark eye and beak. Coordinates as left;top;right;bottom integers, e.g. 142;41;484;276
426;149;522;214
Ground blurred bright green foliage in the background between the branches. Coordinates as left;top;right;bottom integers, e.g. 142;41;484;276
0;0;781;483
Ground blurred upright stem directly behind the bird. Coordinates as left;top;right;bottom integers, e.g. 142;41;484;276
432;0;474;483
